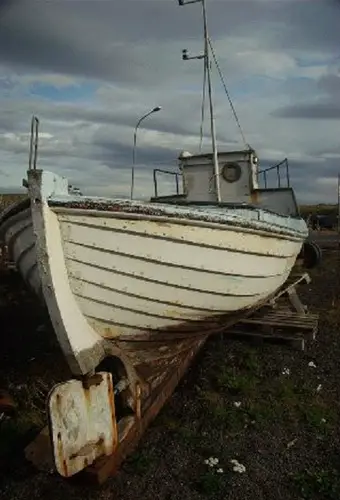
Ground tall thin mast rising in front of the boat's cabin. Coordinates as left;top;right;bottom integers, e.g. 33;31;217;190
178;0;221;203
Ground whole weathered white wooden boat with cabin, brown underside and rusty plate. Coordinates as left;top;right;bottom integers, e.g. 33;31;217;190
0;0;308;476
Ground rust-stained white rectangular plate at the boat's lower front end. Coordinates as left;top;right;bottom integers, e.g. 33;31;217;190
48;372;118;477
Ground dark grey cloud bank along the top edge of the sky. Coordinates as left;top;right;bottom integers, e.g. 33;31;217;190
0;0;340;85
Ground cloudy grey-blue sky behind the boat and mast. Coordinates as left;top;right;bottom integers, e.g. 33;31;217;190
0;0;340;203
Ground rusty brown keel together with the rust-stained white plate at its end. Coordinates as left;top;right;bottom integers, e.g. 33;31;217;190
48;337;206;484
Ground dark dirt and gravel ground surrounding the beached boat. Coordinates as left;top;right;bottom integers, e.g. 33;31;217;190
0;252;340;500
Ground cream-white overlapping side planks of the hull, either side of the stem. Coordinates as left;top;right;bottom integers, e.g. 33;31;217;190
0;201;302;338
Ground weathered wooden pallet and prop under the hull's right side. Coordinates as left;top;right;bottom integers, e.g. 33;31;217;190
228;273;319;351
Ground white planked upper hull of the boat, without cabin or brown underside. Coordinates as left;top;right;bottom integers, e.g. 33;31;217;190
0;160;308;383
